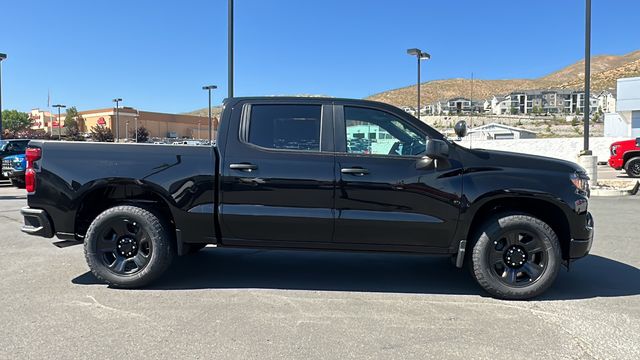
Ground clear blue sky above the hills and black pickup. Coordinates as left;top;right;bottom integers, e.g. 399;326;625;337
0;0;640;112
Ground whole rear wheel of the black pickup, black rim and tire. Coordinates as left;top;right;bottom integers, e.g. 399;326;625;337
84;206;174;288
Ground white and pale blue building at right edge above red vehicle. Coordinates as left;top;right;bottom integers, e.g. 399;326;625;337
604;77;640;138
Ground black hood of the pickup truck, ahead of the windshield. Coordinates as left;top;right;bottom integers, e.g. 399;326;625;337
467;149;586;174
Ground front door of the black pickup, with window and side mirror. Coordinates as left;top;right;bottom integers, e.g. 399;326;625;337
335;105;462;248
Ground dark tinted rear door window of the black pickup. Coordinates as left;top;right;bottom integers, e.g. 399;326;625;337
247;105;322;151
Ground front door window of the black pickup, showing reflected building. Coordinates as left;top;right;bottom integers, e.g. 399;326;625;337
344;106;426;156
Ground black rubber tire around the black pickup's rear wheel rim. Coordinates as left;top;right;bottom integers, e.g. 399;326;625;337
84;205;175;288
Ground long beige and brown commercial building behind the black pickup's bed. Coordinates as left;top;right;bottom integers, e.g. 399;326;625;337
30;107;217;140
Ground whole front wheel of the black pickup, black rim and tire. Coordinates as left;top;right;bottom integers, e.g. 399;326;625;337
471;214;561;300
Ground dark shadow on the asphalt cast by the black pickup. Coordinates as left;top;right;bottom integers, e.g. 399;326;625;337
72;248;640;300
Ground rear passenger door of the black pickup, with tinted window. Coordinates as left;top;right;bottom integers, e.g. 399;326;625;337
219;100;336;246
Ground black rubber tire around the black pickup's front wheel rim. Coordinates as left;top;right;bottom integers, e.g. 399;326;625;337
469;213;562;300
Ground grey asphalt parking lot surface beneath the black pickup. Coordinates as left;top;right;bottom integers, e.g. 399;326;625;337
0;186;640;359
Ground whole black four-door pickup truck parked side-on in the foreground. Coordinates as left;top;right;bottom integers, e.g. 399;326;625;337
17;97;593;299
